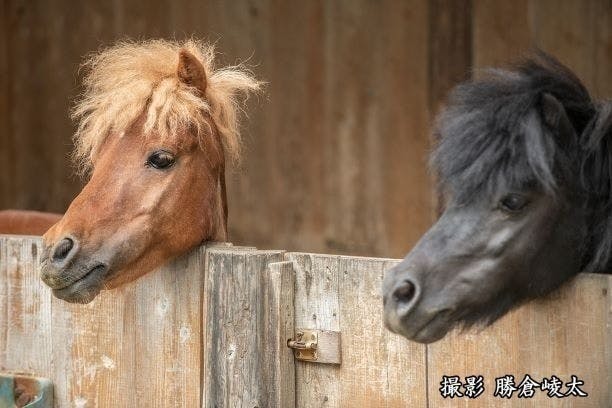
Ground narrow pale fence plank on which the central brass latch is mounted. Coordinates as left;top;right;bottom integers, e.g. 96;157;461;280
286;253;342;407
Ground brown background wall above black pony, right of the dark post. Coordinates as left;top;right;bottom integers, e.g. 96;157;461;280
473;0;612;99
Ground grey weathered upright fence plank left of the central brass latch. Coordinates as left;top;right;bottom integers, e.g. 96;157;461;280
202;249;293;407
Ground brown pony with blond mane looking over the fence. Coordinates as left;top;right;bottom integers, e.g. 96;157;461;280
41;40;260;303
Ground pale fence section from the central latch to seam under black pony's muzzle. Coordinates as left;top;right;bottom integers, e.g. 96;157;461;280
287;253;427;407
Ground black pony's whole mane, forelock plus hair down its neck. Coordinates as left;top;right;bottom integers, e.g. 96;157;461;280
431;51;612;272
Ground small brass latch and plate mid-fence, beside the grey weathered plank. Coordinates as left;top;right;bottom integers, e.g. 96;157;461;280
287;329;342;364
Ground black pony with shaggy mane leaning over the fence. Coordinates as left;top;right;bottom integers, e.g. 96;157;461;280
383;52;612;343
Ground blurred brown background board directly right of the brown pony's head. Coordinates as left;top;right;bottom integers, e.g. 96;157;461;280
209;0;329;255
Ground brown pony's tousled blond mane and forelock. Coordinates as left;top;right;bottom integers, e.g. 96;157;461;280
72;40;262;172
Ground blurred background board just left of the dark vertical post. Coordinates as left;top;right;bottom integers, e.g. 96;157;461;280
318;1;433;255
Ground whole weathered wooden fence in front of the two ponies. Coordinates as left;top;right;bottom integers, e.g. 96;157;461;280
0;236;612;408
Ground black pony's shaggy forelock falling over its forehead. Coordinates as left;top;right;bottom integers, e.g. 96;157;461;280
431;51;595;201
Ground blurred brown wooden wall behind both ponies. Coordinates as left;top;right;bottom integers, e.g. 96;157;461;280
0;0;612;257
